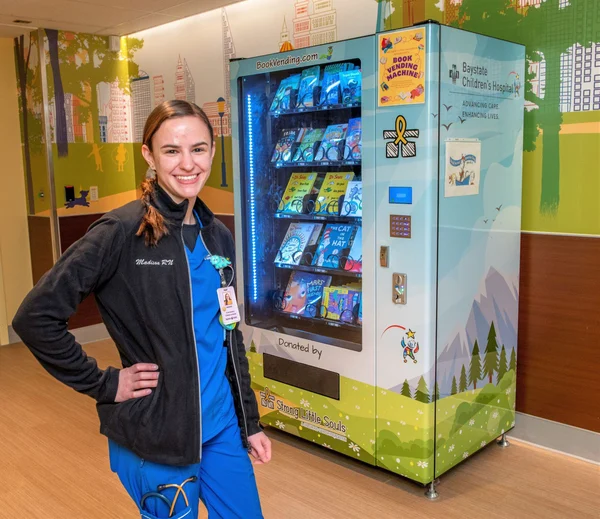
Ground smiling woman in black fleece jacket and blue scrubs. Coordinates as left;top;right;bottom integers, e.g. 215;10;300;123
13;100;271;519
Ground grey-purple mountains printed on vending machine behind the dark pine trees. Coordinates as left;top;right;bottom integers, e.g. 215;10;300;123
391;268;518;398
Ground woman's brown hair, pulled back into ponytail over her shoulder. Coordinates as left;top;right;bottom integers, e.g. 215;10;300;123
136;99;214;247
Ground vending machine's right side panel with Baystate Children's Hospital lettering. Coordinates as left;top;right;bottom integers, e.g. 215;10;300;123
435;27;525;477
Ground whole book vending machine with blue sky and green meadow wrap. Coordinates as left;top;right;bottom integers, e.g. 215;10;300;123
231;23;524;495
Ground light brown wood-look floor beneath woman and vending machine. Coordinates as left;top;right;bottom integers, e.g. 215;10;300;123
0;341;600;519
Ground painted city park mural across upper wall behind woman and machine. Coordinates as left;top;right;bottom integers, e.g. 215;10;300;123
15;0;600;235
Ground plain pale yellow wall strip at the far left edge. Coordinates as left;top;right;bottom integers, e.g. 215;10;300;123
0;38;32;342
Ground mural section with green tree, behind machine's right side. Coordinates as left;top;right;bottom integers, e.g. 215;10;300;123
378;0;600;235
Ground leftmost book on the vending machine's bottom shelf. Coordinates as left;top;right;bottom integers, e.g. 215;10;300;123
283;270;331;317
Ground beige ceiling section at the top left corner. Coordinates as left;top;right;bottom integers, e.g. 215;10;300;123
0;0;243;38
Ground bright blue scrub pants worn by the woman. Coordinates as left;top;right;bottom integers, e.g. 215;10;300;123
109;417;263;519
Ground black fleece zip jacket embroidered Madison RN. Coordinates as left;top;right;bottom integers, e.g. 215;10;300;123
13;185;261;465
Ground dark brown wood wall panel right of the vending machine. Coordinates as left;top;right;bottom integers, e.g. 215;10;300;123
517;234;600;432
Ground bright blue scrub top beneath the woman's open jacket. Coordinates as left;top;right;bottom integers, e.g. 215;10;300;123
185;221;235;443
